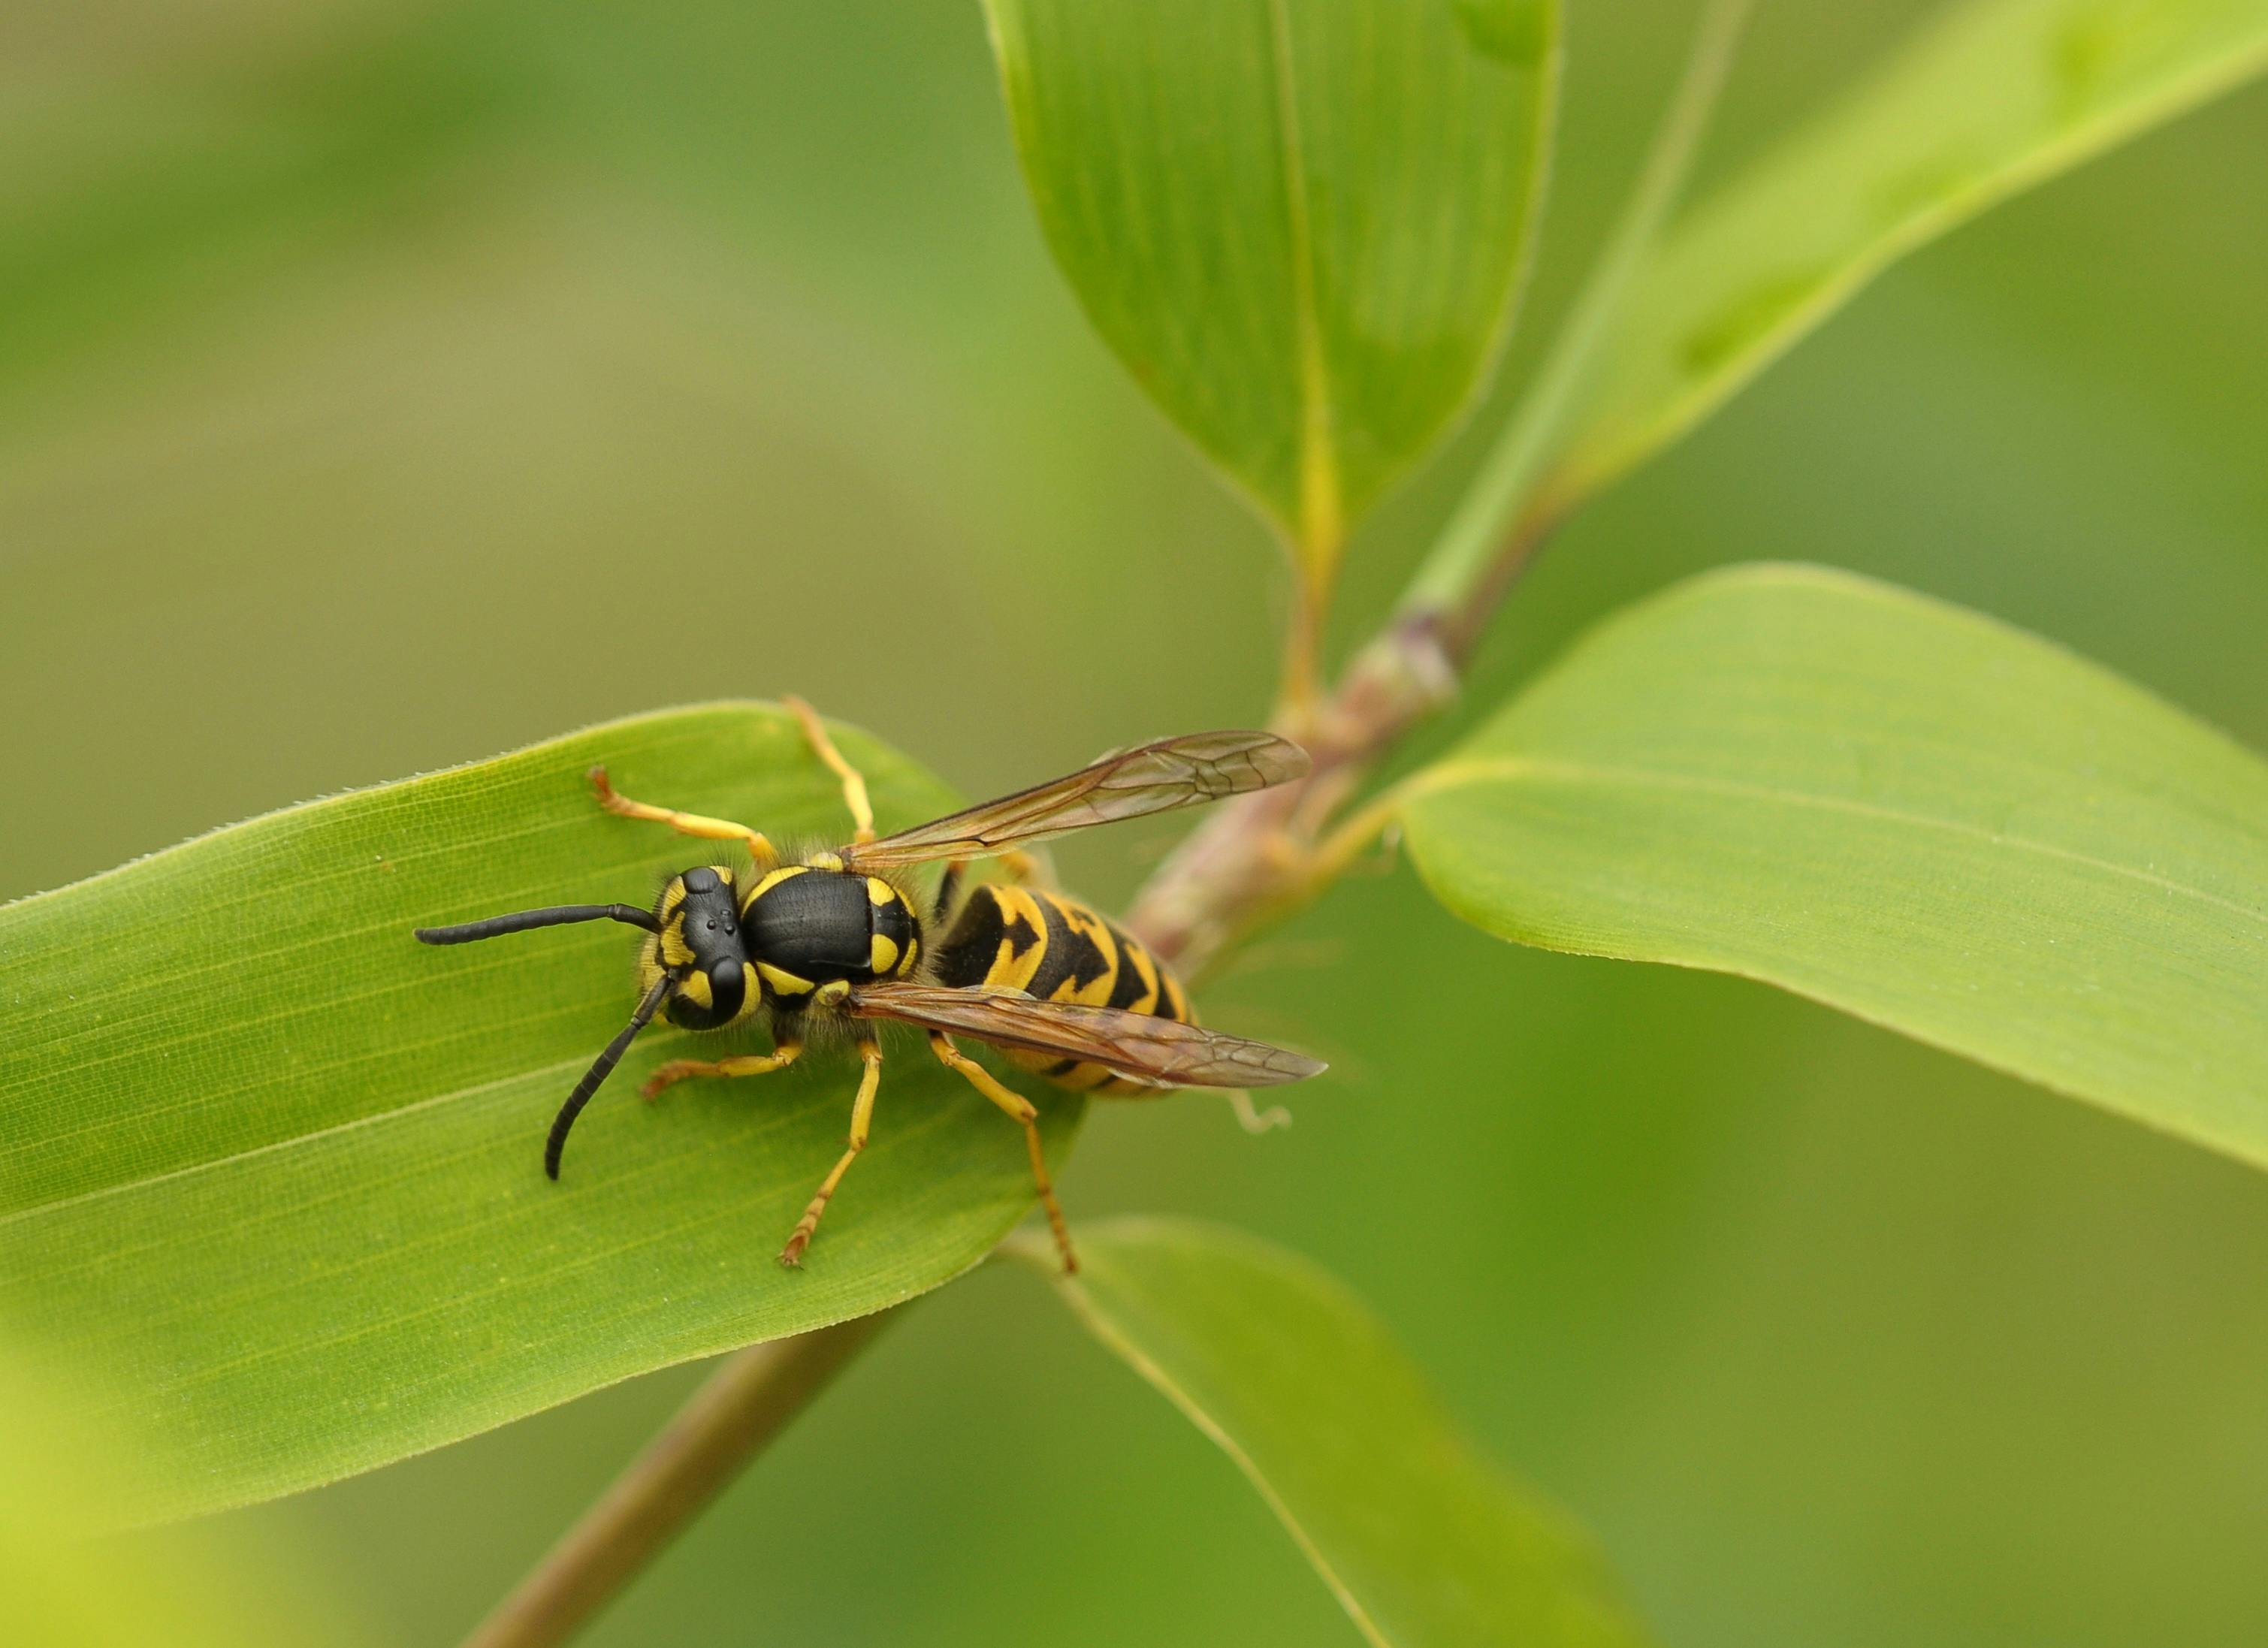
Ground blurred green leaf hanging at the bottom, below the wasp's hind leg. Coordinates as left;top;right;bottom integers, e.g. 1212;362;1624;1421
1009;1220;1647;1648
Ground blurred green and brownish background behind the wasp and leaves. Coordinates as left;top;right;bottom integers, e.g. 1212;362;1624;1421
0;0;2268;1648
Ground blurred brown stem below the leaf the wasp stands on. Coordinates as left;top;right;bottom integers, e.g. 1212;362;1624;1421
465;1310;896;1648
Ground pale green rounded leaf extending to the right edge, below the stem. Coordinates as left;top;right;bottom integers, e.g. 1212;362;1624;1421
1404;566;2268;1165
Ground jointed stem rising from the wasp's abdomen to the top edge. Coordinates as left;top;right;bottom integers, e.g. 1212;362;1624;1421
1129;0;1751;977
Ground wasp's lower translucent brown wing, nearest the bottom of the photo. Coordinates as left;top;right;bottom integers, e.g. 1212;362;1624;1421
850;982;1324;1088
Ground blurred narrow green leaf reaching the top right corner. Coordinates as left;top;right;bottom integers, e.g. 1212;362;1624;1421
1554;0;2268;497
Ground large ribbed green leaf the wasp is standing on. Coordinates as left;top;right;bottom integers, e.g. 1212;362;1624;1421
0;705;1077;1514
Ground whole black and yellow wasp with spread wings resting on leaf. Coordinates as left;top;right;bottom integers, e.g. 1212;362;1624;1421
417;699;1322;1269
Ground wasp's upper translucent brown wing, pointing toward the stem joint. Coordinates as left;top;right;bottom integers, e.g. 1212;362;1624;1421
841;732;1306;871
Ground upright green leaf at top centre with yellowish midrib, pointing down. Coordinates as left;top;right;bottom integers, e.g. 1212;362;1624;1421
986;0;1560;576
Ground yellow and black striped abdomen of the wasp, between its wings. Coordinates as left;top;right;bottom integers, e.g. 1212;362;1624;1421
935;884;1197;1093
